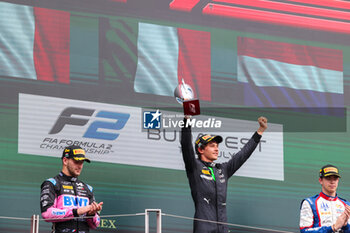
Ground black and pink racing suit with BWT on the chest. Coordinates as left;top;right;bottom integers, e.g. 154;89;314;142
40;172;100;233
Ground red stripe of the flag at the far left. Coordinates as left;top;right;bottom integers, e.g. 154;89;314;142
34;7;70;83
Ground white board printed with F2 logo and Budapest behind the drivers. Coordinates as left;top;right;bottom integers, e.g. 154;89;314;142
18;94;284;180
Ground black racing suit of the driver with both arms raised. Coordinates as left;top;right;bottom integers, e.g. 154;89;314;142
181;120;261;233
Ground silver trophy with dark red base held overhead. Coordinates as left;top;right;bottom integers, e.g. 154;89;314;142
174;79;200;116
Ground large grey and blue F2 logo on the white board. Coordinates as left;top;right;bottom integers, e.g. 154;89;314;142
49;107;130;140
